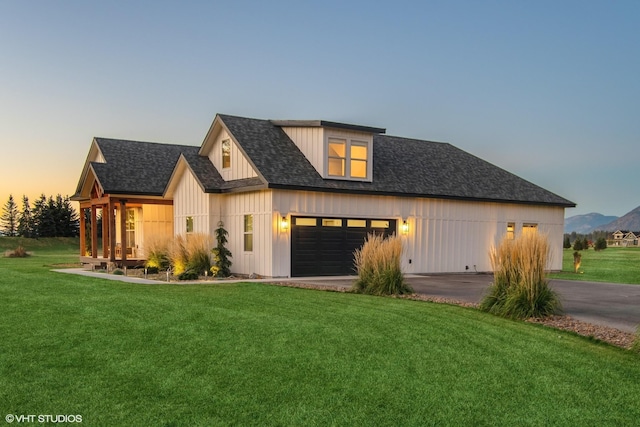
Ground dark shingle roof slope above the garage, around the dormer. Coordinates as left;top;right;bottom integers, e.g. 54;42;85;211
219;115;575;207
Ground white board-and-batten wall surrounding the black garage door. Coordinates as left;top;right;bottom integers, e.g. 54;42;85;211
271;190;564;276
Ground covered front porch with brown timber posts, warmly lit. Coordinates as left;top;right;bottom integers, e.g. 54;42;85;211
80;195;173;267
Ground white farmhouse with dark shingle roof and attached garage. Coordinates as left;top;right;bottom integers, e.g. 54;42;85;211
74;114;575;277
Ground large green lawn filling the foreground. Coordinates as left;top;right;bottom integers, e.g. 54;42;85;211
0;244;640;426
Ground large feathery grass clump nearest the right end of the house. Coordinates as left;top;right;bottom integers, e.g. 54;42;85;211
480;233;562;319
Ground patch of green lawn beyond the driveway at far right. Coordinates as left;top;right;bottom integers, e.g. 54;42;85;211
550;247;640;285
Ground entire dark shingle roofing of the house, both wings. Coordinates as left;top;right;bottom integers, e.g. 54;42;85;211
79;114;575;207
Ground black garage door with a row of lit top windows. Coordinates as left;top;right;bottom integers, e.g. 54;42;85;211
291;217;396;277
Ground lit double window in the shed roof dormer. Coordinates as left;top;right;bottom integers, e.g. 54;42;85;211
327;138;369;179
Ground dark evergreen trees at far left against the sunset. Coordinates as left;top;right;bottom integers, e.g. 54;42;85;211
0;194;80;238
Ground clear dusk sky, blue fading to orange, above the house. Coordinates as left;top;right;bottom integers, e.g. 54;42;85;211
0;0;640;216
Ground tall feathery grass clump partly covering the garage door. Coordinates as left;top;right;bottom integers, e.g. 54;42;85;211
353;234;413;295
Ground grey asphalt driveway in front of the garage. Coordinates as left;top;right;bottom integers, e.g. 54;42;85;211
291;274;640;332
